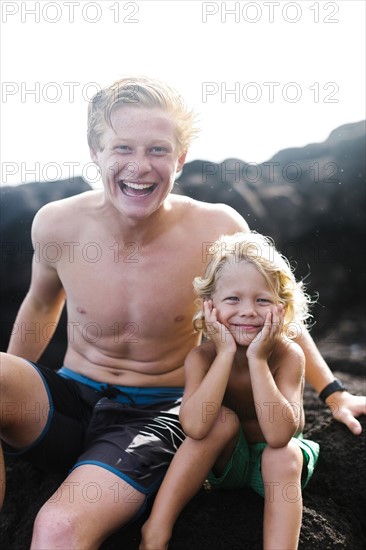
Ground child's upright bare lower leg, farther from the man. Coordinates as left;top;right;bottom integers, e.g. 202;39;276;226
262;441;303;550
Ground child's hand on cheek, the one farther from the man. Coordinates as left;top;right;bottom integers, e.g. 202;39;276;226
247;305;284;360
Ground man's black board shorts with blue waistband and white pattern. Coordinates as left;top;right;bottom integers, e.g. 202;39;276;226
3;363;185;496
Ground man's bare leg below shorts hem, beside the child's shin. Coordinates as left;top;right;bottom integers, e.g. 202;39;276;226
31;464;145;550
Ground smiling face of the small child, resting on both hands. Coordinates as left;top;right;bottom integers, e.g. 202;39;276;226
212;261;275;346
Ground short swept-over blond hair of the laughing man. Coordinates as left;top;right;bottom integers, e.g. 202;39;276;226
88;77;198;154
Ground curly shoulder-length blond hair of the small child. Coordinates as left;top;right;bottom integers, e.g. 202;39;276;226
193;231;313;338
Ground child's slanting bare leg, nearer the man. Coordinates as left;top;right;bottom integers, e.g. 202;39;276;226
140;408;240;550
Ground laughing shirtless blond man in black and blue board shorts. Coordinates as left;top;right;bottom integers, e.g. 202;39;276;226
0;79;365;550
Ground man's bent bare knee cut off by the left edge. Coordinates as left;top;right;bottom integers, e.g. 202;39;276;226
0;353;49;504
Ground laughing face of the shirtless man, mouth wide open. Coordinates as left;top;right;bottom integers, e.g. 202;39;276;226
91;104;185;219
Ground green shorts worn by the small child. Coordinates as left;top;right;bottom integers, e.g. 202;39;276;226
207;430;319;497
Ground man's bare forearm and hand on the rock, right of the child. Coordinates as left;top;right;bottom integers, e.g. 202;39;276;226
298;330;366;435
